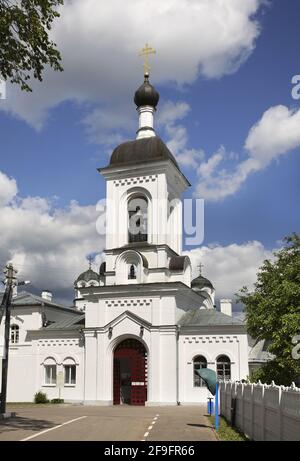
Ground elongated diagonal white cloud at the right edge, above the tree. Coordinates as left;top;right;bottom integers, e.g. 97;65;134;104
195;105;300;201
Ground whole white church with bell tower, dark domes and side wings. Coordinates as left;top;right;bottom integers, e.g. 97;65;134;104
0;73;249;405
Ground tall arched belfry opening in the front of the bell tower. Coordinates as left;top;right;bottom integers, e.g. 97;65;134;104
128;196;148;243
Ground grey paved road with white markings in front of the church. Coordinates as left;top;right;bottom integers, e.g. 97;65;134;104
0;405;216;441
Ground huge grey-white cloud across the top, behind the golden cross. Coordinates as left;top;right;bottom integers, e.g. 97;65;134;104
1;0;263;136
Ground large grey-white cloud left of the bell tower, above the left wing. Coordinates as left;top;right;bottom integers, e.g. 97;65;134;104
0;173;104;303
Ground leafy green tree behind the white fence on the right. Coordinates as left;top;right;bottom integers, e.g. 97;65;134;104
238;233;300;385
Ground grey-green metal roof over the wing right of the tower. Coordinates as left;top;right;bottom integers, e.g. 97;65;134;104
178;309;244;327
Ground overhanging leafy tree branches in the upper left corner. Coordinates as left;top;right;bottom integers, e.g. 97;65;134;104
0;0;63;91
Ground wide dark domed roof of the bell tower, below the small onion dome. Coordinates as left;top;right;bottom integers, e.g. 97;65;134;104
109;136;179;169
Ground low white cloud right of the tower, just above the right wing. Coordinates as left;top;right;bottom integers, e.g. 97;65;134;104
185;241;272;300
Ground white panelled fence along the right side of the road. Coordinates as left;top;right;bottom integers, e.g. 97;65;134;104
220;382;300;441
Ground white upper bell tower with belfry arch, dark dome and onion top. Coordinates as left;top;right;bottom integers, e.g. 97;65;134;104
98;63;191;286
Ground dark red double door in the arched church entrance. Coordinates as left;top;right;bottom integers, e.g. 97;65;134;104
113;339;147;405
